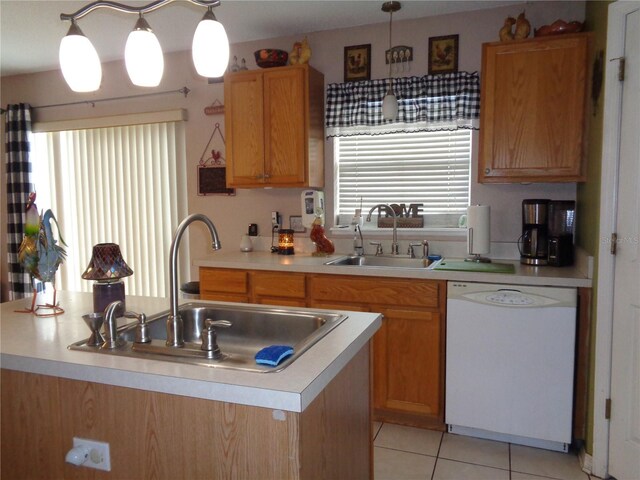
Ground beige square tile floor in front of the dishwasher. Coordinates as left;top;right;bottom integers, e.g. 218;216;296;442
373;422;596;480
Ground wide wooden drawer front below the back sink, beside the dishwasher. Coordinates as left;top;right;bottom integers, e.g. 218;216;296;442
311;275;444;308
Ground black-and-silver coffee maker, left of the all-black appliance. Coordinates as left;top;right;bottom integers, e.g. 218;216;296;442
519;199;550;265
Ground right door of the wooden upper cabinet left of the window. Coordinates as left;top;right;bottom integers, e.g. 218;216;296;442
264;68;308;186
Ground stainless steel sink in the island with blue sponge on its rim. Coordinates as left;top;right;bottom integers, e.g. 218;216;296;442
68;302;347;372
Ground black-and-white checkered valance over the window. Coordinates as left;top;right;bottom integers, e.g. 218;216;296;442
325;72;480;137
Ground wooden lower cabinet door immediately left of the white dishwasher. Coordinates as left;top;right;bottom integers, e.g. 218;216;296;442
373;308;444;428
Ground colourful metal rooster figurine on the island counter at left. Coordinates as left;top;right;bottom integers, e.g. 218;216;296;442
18;192;67;317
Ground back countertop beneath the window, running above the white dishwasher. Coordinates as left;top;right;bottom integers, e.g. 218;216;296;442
193;250;591;287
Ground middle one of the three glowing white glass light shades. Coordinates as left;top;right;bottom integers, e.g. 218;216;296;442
124;17;164;87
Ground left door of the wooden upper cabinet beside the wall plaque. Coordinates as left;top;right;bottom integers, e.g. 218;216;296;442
224;71;265;187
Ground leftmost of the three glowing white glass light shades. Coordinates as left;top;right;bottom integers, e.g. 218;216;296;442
59;22;102;92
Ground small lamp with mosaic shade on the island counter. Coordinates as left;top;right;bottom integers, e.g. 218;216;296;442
82;243;133;315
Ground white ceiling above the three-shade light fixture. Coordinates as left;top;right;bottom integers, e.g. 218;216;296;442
0;0;523;76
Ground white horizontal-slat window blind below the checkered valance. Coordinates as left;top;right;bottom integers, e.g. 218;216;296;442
334;129;471;227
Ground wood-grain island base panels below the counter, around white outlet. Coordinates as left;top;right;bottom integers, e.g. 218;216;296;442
0;346;373;480
